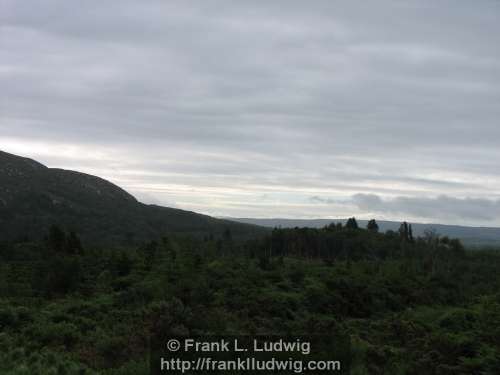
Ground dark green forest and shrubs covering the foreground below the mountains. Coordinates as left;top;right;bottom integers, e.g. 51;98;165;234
0;218;500;375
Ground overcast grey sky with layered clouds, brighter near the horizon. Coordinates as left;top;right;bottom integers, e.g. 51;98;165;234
0;0;500;226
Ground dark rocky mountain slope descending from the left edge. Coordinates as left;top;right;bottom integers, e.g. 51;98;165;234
0;151;266;245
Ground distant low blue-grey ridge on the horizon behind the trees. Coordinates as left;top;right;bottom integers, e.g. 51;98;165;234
230;218;500;247
